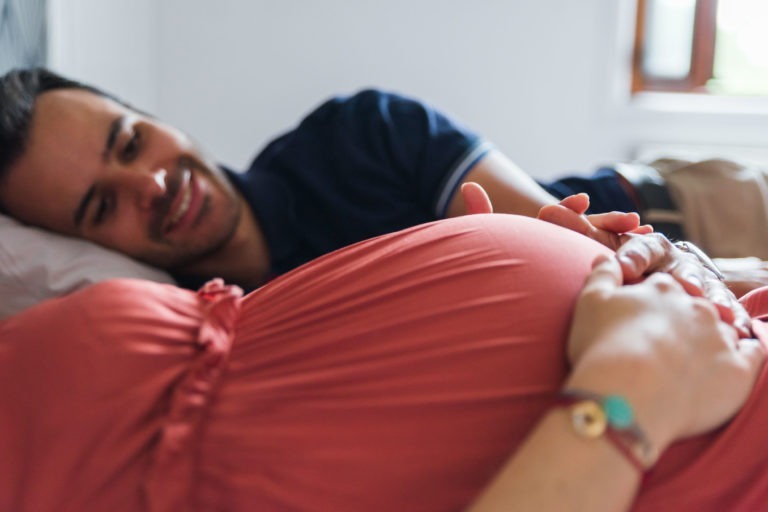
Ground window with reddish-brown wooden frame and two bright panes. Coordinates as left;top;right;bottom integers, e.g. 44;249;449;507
632;0;768;96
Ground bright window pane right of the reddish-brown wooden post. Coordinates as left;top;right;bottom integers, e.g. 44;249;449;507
707;0;768;95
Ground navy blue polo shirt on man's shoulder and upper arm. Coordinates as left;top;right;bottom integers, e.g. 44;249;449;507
173;90;491;286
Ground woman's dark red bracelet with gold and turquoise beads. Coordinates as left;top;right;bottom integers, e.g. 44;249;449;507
555;389;658;473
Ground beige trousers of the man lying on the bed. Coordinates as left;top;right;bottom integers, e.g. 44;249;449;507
650;159;768;259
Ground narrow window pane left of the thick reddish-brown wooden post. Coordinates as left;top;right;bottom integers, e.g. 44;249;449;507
642;0;700;80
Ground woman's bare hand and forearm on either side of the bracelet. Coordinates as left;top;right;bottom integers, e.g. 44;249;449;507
470;257;765;512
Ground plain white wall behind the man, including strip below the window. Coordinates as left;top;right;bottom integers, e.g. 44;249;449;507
46;0;768;176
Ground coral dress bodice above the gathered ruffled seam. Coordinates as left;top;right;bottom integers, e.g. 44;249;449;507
0;279;242;512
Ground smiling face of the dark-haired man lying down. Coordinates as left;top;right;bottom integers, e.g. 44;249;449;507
0;89;242;269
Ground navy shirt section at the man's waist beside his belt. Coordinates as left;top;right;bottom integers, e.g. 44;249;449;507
539;167;638;213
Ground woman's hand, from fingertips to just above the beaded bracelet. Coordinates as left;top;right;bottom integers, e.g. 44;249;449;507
566;258;765;450
